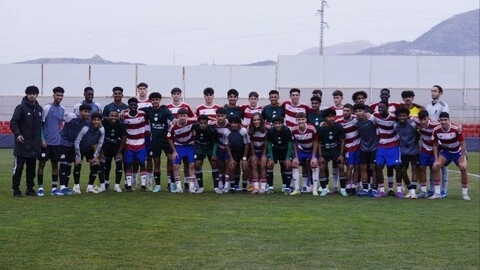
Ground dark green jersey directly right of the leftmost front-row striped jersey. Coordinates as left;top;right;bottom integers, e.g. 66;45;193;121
140;105;174;140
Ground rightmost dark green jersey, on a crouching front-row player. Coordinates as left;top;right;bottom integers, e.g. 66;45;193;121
318;122;345;156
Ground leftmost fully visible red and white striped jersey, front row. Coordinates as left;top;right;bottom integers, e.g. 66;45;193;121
122;109;149;150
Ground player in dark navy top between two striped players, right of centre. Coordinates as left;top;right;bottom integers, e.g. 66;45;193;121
353;103;378;197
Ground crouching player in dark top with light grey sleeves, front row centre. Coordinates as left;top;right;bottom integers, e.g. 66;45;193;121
223;116;250;193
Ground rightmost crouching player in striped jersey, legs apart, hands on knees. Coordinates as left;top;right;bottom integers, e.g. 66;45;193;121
429;112;470;201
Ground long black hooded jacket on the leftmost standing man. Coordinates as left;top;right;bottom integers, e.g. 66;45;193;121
10;96;43;158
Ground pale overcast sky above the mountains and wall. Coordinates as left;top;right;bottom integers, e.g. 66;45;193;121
0;0;479;65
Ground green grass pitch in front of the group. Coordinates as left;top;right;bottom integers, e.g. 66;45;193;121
0;149;480;269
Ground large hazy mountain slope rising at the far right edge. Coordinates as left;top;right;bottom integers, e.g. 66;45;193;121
357;9;480;55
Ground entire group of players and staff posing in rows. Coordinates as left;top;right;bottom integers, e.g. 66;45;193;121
10;82;470;200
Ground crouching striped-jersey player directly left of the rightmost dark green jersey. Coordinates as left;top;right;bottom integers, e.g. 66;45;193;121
290;112;319;196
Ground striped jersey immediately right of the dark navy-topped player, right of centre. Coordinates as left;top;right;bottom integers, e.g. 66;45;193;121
373;113;400;148
